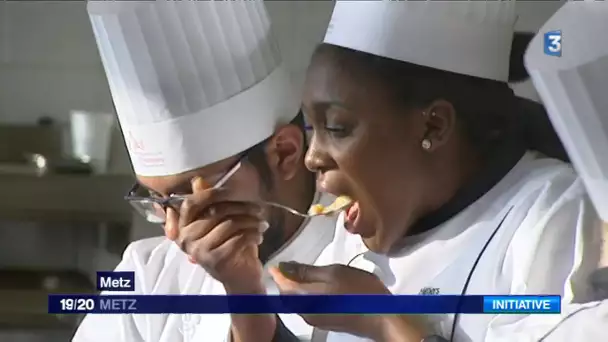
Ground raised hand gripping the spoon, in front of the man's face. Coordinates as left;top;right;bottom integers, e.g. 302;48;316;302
165;178;268;294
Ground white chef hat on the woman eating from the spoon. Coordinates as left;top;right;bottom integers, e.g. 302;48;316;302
324;0;515;82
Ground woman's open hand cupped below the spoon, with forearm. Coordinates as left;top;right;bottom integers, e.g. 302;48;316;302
270;262;423;342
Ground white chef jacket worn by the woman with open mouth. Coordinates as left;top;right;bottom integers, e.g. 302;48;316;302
315;152;608;342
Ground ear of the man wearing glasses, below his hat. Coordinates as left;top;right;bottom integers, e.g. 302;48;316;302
267;124;305;180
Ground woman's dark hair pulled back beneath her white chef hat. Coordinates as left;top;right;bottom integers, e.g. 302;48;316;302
313;38;568;161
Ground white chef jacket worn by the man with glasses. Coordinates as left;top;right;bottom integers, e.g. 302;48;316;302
72;195;336;342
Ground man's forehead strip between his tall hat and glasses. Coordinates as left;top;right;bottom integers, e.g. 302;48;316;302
137;156;237;196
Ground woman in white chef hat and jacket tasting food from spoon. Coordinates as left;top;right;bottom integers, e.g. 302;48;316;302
268;1;601;342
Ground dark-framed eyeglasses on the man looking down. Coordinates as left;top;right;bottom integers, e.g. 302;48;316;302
125;153;247;224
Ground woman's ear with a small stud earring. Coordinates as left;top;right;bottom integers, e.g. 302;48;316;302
421;100;456;151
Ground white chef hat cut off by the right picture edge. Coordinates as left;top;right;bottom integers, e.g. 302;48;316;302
525;1;608;221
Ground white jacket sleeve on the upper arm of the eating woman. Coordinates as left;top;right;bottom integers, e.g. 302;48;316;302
485;179;606;342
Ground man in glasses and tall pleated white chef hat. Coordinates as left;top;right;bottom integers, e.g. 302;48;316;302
74;0;335;342
